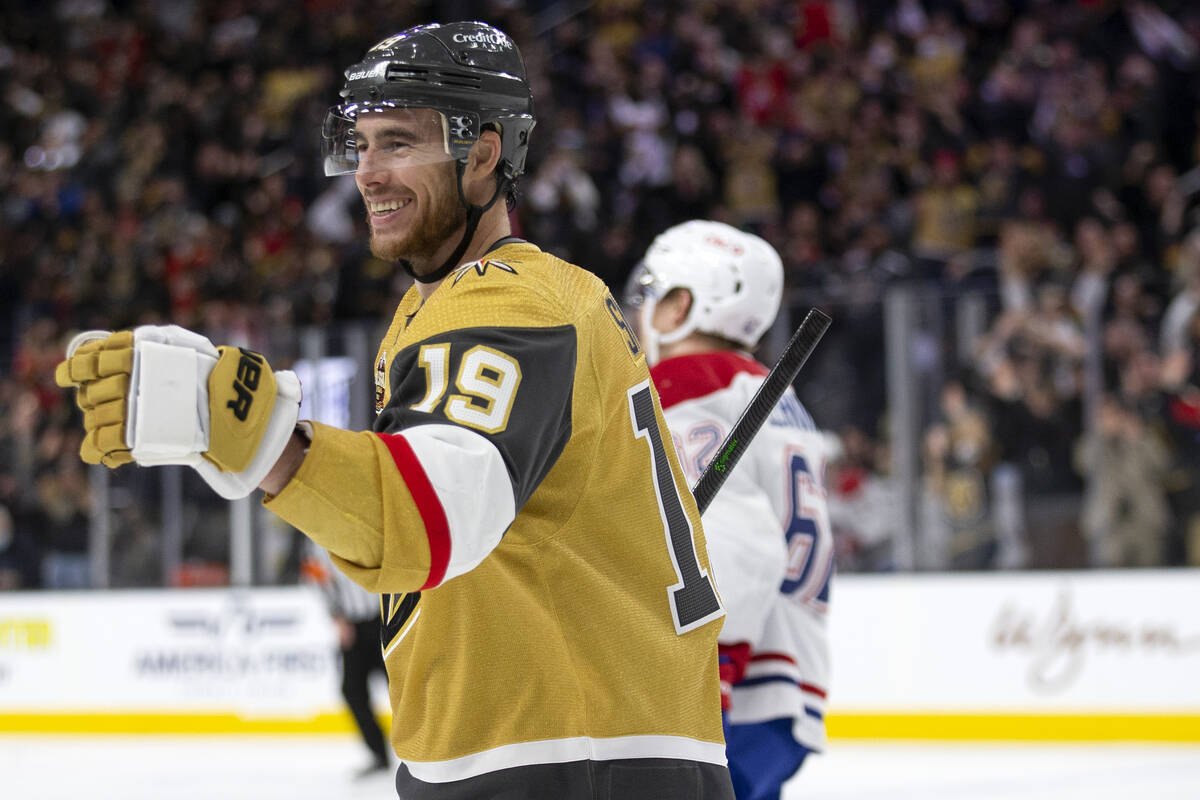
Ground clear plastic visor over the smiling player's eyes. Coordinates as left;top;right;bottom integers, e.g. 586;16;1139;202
320;101;465;175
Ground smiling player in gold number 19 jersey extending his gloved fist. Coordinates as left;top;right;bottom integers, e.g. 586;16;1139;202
58;23;733;800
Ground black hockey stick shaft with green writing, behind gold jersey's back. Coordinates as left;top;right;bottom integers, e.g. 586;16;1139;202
691;308;833;513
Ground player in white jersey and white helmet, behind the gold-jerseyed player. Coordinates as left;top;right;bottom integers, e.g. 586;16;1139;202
630;219;834;800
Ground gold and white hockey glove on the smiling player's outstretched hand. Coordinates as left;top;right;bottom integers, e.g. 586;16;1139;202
54;325;300;500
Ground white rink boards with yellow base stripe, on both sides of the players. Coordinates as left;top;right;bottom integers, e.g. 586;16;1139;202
0;570;1200;742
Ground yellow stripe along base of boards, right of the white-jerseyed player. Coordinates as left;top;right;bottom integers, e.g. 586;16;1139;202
826;714;1200;742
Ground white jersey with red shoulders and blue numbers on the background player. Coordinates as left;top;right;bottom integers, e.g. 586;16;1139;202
652;350;834;751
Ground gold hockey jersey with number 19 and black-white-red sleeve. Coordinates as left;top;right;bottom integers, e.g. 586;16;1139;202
268;240;725;782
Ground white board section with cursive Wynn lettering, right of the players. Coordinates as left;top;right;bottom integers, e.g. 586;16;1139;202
828;570;1200;742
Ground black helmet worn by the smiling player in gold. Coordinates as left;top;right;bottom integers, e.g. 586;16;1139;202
322;22;534;181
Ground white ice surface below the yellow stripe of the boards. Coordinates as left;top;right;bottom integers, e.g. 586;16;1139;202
0;734;1200;800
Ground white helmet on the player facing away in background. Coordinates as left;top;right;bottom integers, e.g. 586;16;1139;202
630;219;784;363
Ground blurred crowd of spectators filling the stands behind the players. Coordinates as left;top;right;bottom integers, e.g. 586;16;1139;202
0;0;1200;589
